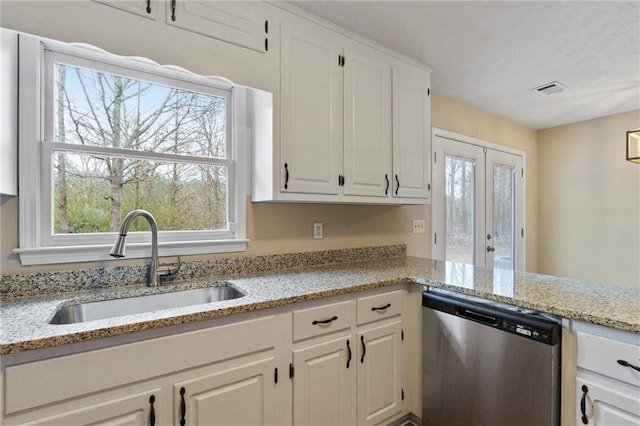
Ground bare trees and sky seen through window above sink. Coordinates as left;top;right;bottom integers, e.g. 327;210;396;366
52;64;229;234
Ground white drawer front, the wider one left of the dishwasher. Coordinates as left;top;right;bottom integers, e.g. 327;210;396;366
293;300;353;342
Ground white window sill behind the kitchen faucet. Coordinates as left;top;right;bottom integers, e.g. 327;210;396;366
13;239;249;266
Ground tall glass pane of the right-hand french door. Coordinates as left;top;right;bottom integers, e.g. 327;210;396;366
493;165;515;270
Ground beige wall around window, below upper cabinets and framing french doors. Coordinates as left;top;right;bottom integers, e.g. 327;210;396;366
0;0;538;273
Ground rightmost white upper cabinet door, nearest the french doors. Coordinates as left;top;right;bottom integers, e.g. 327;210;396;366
392;63;431;199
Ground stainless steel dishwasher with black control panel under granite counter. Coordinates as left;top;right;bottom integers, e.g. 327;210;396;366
422;288;561;426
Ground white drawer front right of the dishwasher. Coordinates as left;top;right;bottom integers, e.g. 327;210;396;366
577;332;640;386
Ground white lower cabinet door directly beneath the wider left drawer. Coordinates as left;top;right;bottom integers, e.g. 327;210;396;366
293;336;357;426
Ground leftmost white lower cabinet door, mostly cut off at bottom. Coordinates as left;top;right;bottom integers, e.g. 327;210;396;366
20;389;164;426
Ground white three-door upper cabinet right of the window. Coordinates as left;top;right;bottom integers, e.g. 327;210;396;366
252;15;431;204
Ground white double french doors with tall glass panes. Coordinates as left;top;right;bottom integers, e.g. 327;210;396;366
432;130;525;271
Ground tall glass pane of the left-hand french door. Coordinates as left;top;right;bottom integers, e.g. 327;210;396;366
445;155;475;264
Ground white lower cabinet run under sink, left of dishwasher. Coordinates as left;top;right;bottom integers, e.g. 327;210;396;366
0;286;418;426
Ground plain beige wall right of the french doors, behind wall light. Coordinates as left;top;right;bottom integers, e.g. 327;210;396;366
538;110;640;287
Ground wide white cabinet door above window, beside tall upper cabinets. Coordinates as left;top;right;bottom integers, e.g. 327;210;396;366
166;0;269;53
